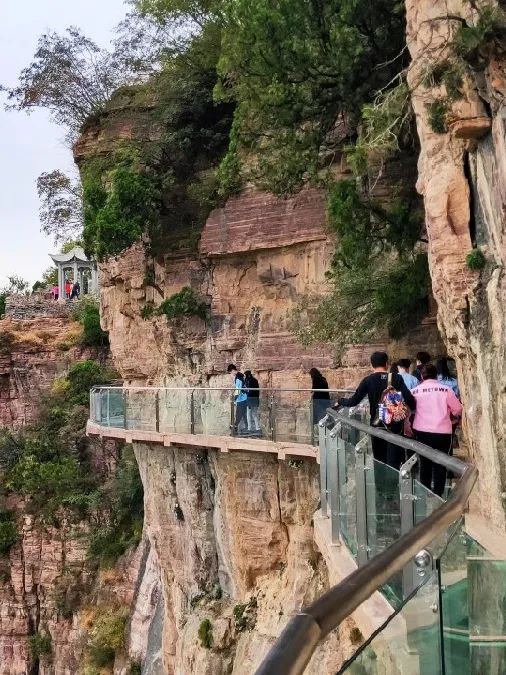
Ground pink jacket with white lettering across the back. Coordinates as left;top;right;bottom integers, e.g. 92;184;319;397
411;380;462;434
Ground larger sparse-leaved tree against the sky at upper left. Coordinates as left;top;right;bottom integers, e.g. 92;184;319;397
1;27;127;135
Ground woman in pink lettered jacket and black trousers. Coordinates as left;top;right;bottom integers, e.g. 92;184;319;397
411;363;462;496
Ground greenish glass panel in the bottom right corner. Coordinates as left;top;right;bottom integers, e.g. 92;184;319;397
467;556;506;675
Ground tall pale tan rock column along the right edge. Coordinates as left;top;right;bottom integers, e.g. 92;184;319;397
406;0;506;529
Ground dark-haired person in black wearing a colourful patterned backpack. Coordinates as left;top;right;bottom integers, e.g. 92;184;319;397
338;352;416;468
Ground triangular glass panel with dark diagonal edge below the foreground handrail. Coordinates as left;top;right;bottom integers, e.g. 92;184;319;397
340;573;443;675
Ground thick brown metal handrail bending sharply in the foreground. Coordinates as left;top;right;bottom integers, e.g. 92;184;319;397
256;409;478;675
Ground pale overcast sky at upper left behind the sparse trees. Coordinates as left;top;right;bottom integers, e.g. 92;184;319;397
0;0;127;288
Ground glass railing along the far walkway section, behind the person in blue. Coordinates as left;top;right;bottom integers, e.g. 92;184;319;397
90;386;349;445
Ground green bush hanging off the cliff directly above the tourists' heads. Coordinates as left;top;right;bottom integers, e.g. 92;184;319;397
293;181;430;351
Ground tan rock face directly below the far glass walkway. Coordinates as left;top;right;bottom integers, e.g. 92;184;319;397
135;444;352;675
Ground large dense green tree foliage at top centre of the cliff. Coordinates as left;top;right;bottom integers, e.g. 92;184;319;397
217;0;407;193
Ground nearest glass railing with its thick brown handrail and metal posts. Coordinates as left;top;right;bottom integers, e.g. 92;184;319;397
257;410;478;675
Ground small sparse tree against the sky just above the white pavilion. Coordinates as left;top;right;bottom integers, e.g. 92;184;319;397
37;169;83;244
